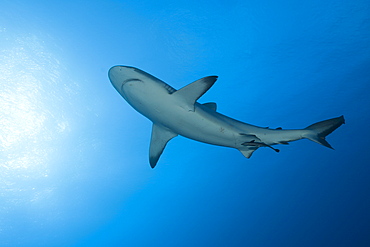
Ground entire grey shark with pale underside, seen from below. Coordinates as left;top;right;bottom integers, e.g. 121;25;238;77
108;66;344;168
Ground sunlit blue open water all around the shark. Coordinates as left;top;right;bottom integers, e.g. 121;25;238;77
0;0;370;247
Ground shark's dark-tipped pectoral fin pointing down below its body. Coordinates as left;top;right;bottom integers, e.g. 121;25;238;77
149;124;177;168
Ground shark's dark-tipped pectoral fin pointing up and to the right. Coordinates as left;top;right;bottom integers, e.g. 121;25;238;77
173;76;218;111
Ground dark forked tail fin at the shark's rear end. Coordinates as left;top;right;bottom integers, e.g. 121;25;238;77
304;116;344;149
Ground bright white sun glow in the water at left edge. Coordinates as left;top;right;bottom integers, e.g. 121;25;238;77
0;32;68;199
